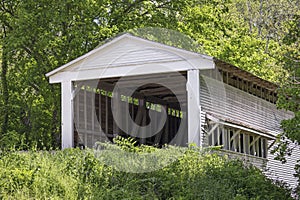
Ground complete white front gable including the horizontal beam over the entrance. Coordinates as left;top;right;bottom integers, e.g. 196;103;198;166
46;34;215;83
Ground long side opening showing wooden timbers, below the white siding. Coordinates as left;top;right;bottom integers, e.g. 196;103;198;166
208;124;268;158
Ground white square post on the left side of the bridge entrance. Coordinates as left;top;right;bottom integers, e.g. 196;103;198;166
61;80;74;149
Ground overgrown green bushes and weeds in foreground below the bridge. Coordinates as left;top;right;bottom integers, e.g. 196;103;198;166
0;140;291;200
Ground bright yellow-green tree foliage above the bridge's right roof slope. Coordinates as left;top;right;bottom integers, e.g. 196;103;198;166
178;0;286;82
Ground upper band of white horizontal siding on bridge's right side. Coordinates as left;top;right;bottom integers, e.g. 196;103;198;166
200;76;293;136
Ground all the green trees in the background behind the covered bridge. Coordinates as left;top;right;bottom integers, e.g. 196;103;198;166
0;0;300;149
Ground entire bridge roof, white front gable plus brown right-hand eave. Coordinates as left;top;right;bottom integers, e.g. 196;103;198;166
46;33;278;91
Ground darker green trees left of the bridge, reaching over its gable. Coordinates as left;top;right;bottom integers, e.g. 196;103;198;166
0;0;196;148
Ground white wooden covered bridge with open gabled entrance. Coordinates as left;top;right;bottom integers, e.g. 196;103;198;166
47;34;297;186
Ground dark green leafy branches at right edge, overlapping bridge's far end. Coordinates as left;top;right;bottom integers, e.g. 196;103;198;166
276;12;300;193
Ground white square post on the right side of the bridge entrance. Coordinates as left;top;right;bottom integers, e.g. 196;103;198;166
186;69;201;146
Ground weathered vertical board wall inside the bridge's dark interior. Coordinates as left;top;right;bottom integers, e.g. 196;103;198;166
74;83;187;147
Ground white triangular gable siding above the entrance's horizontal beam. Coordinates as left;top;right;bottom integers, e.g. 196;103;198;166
46;34;214;78
